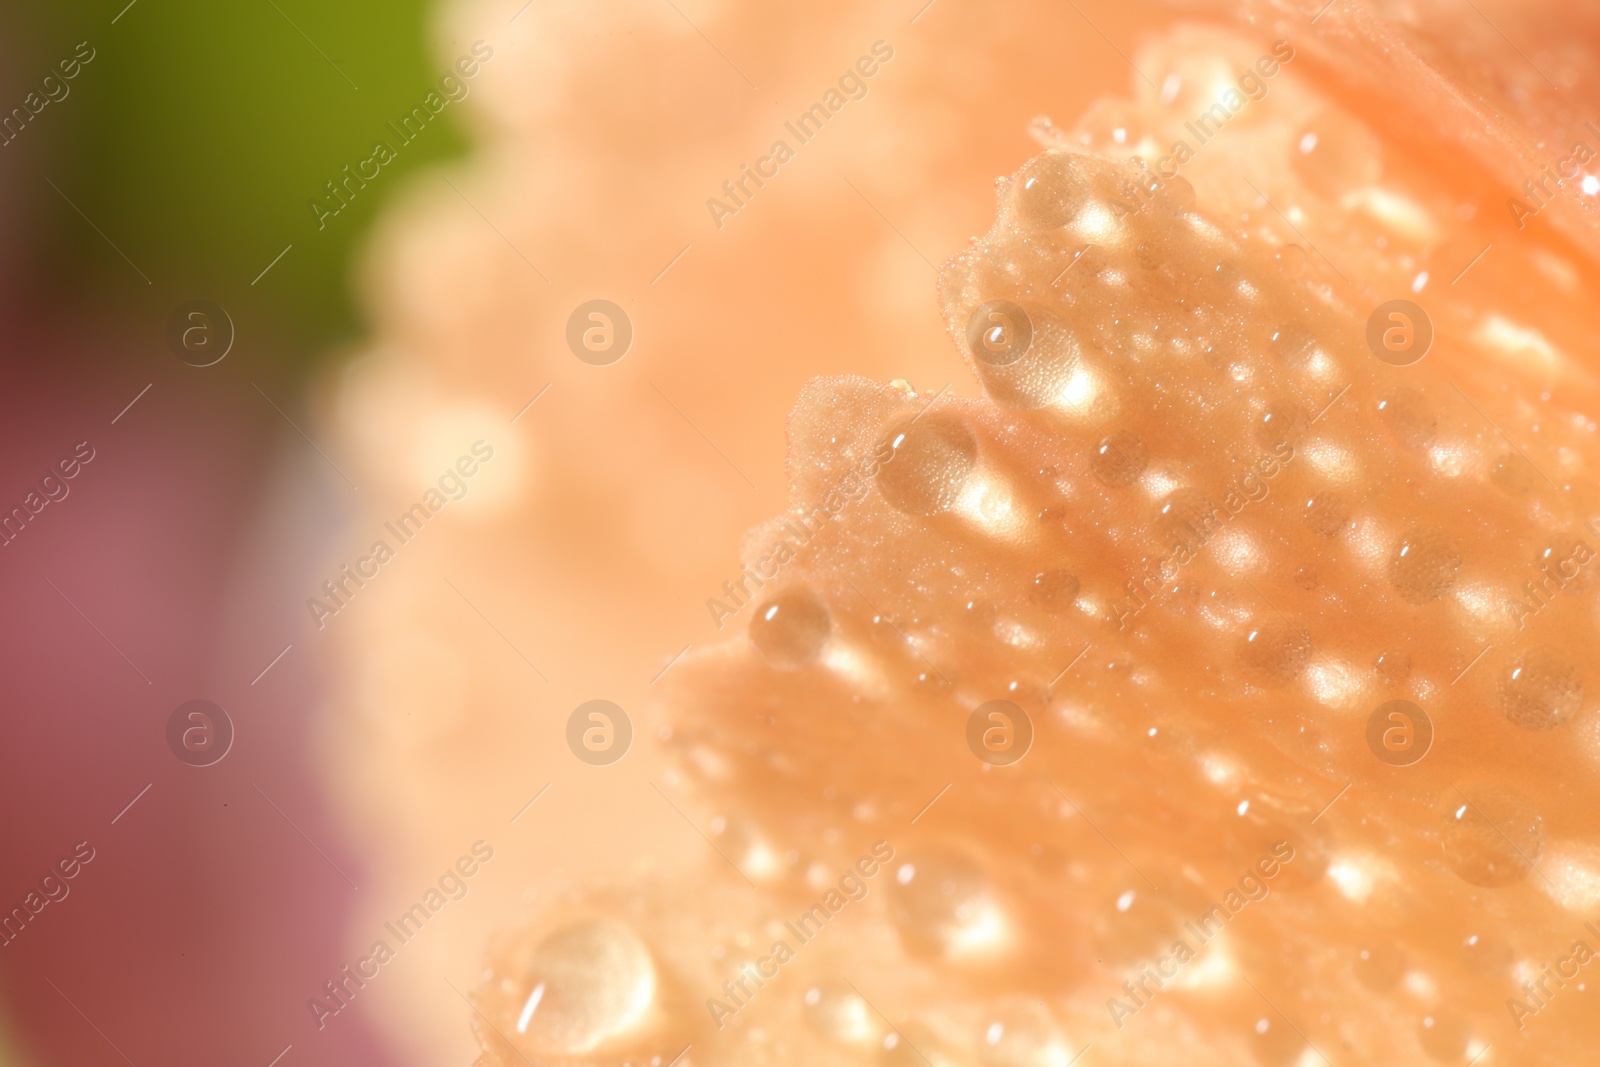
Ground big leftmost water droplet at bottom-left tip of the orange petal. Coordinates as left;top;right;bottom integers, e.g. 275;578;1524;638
515;918;656;1056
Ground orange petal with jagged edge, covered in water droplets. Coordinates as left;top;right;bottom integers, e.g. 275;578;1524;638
321;3;1600;1067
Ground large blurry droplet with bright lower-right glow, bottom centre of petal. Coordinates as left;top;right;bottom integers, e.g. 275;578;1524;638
890;848;1000;957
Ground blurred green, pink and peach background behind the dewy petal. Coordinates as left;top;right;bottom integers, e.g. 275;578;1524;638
0;0;1388;1067
